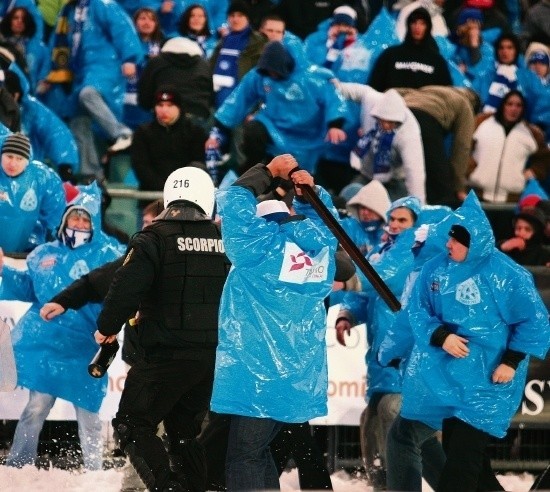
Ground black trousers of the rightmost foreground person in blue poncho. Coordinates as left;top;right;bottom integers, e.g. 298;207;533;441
436;417;504;492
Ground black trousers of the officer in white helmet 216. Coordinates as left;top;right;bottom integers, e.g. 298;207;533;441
113;351;215;491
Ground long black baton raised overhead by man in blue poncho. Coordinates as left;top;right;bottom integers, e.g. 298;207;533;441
297;184;401;313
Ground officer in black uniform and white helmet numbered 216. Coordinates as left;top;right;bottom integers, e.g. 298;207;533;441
95;167;229;491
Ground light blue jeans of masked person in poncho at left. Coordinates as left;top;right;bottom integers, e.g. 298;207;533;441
6;391;103;470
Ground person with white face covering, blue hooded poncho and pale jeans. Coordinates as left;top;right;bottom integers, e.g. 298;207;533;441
2;183;124;470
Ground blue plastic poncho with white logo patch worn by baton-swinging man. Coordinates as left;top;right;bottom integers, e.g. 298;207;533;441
211;186;337;422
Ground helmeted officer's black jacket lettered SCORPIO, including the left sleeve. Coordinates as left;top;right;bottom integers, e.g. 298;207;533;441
97;202;230;358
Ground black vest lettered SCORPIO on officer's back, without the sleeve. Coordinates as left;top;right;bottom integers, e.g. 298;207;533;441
139;220;230;350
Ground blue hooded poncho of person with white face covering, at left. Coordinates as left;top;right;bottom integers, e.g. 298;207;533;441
2;183;124;412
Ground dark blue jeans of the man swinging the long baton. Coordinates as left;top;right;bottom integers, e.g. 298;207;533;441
225;415;283;492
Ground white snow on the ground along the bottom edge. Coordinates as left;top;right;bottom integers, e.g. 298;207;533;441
0;466;534;492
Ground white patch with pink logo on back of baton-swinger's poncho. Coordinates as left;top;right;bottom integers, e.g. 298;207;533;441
279;243;329;284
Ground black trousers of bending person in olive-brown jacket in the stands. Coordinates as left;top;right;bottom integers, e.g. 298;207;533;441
411;108;457;205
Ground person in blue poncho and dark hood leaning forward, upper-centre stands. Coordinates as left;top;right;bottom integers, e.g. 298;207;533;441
207;41;346;172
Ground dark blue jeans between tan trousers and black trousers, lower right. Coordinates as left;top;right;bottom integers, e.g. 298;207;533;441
386;415;445;492
